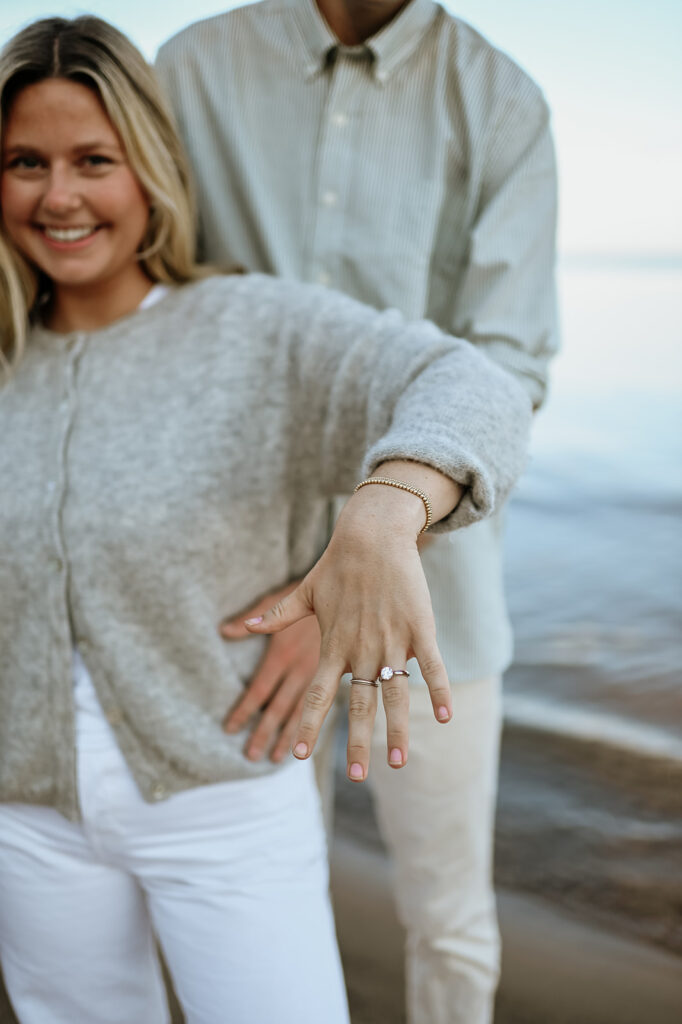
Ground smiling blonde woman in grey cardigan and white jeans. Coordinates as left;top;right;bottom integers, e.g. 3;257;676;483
0;17;530;1024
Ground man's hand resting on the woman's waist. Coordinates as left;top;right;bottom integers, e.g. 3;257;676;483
220;583;319;762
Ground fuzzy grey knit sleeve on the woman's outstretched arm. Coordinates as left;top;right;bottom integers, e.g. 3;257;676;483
256;279;531;529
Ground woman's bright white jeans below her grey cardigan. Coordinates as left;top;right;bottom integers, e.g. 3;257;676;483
0;675;348;1024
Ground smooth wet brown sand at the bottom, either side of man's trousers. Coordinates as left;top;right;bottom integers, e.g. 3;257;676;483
332;837;682;1024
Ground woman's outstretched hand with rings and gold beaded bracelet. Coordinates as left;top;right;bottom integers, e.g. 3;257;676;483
236;462;461;781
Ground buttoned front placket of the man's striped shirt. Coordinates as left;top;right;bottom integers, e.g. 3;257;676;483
304;49;371;288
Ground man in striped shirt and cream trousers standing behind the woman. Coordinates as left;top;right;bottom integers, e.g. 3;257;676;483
159;0;555;1024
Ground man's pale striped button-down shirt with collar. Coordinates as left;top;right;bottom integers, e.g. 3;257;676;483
158;0;556;680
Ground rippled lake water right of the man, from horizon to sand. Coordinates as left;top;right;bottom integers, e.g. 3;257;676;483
497;265;682;951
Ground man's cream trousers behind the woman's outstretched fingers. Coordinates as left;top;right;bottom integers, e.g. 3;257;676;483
369;678;502;1024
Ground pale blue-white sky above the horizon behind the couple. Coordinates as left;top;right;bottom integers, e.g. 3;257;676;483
0;0;682;255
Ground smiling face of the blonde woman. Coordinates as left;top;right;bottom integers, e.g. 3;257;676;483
0;78;150;305
